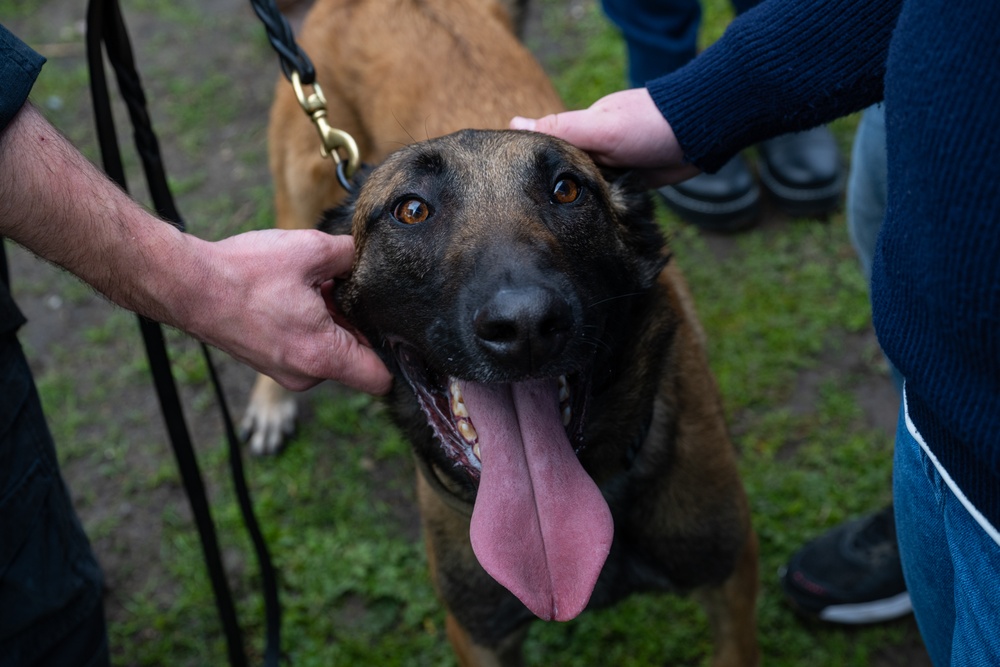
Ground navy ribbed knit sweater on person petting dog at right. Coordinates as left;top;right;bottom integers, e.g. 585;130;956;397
647;0;1000;528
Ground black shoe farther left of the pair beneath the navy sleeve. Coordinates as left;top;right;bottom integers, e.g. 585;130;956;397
659;155;760;232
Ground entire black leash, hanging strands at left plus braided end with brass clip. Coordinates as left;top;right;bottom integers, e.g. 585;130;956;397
84;0;368;667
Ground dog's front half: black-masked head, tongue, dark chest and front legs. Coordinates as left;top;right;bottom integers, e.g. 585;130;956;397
323;130;757;665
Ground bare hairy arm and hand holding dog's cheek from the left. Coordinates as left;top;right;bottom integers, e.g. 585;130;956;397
0;105;390;393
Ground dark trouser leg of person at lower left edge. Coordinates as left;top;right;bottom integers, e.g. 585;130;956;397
0;334;109;667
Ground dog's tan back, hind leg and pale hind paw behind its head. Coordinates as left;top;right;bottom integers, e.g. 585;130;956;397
243;0;562;454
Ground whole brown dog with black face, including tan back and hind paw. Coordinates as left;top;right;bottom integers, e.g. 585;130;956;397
245;0;757;665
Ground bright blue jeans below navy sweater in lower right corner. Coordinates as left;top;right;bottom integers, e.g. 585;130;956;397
893;393;1000;667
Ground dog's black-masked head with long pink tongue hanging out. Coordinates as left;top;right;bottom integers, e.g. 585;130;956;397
324;130;666;619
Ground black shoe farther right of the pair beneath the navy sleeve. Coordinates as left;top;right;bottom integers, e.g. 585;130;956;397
757;127;844;216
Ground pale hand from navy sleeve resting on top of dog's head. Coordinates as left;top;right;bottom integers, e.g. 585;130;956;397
510;88;698;186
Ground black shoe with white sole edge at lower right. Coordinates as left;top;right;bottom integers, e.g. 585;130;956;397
778;505;913;624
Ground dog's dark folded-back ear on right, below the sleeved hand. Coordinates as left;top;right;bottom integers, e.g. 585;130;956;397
601;167;670;284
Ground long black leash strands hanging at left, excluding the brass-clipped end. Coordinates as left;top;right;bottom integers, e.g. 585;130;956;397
87;0;281;667
